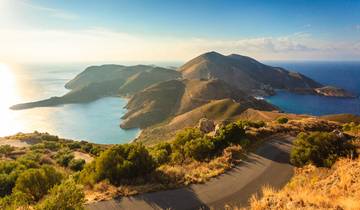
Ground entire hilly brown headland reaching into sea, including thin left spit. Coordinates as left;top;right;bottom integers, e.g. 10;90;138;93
11;52;356;141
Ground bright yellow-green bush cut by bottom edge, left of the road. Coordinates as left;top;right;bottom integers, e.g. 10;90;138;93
35;179;85;210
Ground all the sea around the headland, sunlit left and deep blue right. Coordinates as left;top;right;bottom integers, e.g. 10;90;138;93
0;61;360;144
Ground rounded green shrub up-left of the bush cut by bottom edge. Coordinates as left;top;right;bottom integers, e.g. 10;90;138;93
14;166;62;201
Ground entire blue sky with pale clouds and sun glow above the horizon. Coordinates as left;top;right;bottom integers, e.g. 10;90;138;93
0;0;360;63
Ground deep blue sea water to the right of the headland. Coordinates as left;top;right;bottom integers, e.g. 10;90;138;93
266;62;360;115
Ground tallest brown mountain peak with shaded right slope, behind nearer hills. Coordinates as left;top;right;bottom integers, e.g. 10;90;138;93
179;52;322;95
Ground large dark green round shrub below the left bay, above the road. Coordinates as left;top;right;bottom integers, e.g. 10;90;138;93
88;144;155;185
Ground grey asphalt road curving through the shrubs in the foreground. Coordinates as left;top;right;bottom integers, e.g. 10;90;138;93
86;136;293;210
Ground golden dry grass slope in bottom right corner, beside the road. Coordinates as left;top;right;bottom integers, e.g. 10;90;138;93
250;159;360;210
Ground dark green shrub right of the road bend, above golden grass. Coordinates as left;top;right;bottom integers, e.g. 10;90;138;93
290;132;356;167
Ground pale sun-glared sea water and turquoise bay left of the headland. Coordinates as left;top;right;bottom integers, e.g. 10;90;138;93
0;64;139;144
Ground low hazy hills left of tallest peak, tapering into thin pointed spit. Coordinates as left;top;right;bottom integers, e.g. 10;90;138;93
11;65;181;110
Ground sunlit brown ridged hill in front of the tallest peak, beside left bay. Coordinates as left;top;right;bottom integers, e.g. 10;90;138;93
121;79;277;128
